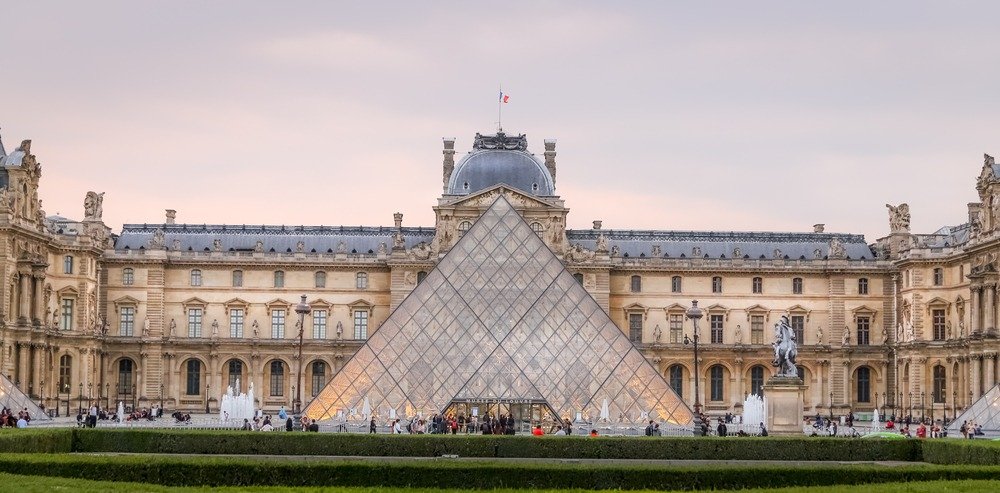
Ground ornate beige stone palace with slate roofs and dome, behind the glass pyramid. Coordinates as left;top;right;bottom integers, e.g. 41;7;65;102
0;132;1000;418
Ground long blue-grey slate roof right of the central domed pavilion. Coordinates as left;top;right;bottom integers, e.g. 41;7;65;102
566;229;875;260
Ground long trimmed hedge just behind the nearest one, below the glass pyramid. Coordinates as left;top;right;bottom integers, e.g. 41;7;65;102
73;429;922;462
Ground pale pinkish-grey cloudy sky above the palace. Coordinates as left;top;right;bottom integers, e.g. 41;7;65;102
0;1;1000;241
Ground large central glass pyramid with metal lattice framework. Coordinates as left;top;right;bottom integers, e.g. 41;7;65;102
305;195;692;425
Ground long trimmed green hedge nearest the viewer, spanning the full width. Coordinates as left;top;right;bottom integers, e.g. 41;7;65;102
0;454;1000;490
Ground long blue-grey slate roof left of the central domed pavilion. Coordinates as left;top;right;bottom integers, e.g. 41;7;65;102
115;224;434;253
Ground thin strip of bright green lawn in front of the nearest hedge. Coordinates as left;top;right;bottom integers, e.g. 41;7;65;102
0;473;1000;493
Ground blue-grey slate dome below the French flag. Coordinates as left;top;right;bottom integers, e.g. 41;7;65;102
448;132;555;196
